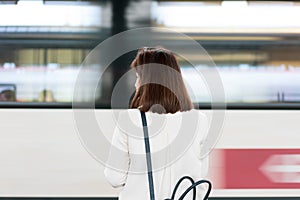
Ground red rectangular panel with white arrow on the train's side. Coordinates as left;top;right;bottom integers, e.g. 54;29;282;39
222;149;300;189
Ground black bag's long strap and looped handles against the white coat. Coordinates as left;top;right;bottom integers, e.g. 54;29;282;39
141;111;212;200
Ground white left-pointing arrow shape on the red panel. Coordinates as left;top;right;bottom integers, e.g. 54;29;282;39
259;154;300;183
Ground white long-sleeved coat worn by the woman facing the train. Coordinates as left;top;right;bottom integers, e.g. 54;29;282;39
104;109;208;200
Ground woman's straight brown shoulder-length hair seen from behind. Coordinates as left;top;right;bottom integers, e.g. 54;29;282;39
130;47;193;114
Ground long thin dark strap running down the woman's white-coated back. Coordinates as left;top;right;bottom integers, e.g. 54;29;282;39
141;111;155;200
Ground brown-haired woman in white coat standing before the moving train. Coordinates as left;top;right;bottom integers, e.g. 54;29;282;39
104;47;208;200
